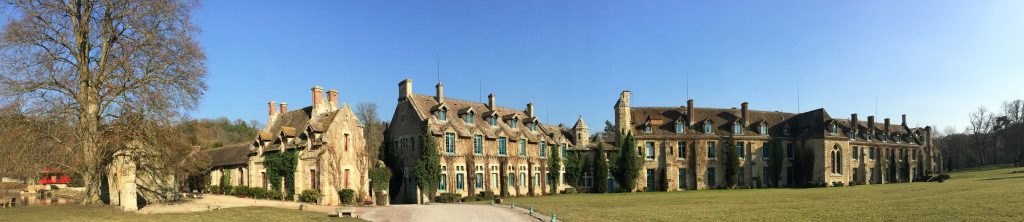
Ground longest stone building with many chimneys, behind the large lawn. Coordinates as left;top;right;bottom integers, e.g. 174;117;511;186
602;91;941;191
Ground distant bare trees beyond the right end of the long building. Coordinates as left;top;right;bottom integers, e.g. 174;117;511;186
934;99;1024;170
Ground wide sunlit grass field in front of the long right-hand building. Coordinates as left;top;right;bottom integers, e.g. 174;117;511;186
508;167;1024;221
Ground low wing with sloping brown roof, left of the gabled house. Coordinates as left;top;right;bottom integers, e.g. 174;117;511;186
205;142;252;186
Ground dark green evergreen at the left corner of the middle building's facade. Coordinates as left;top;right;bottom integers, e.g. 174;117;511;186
416;124;441;199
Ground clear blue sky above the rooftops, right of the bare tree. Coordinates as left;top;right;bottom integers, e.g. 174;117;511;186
9;0;1024;130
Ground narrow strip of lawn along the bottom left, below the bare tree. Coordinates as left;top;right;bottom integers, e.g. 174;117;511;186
0;205;358;222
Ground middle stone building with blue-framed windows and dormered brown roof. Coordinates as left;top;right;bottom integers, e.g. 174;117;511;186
387;80;573;203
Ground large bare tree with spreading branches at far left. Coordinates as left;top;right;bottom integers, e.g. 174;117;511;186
0;0;206;204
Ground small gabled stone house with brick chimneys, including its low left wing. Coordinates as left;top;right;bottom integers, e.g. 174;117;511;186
208;86;372;206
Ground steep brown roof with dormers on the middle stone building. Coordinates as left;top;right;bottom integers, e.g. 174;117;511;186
409;94;560;142
